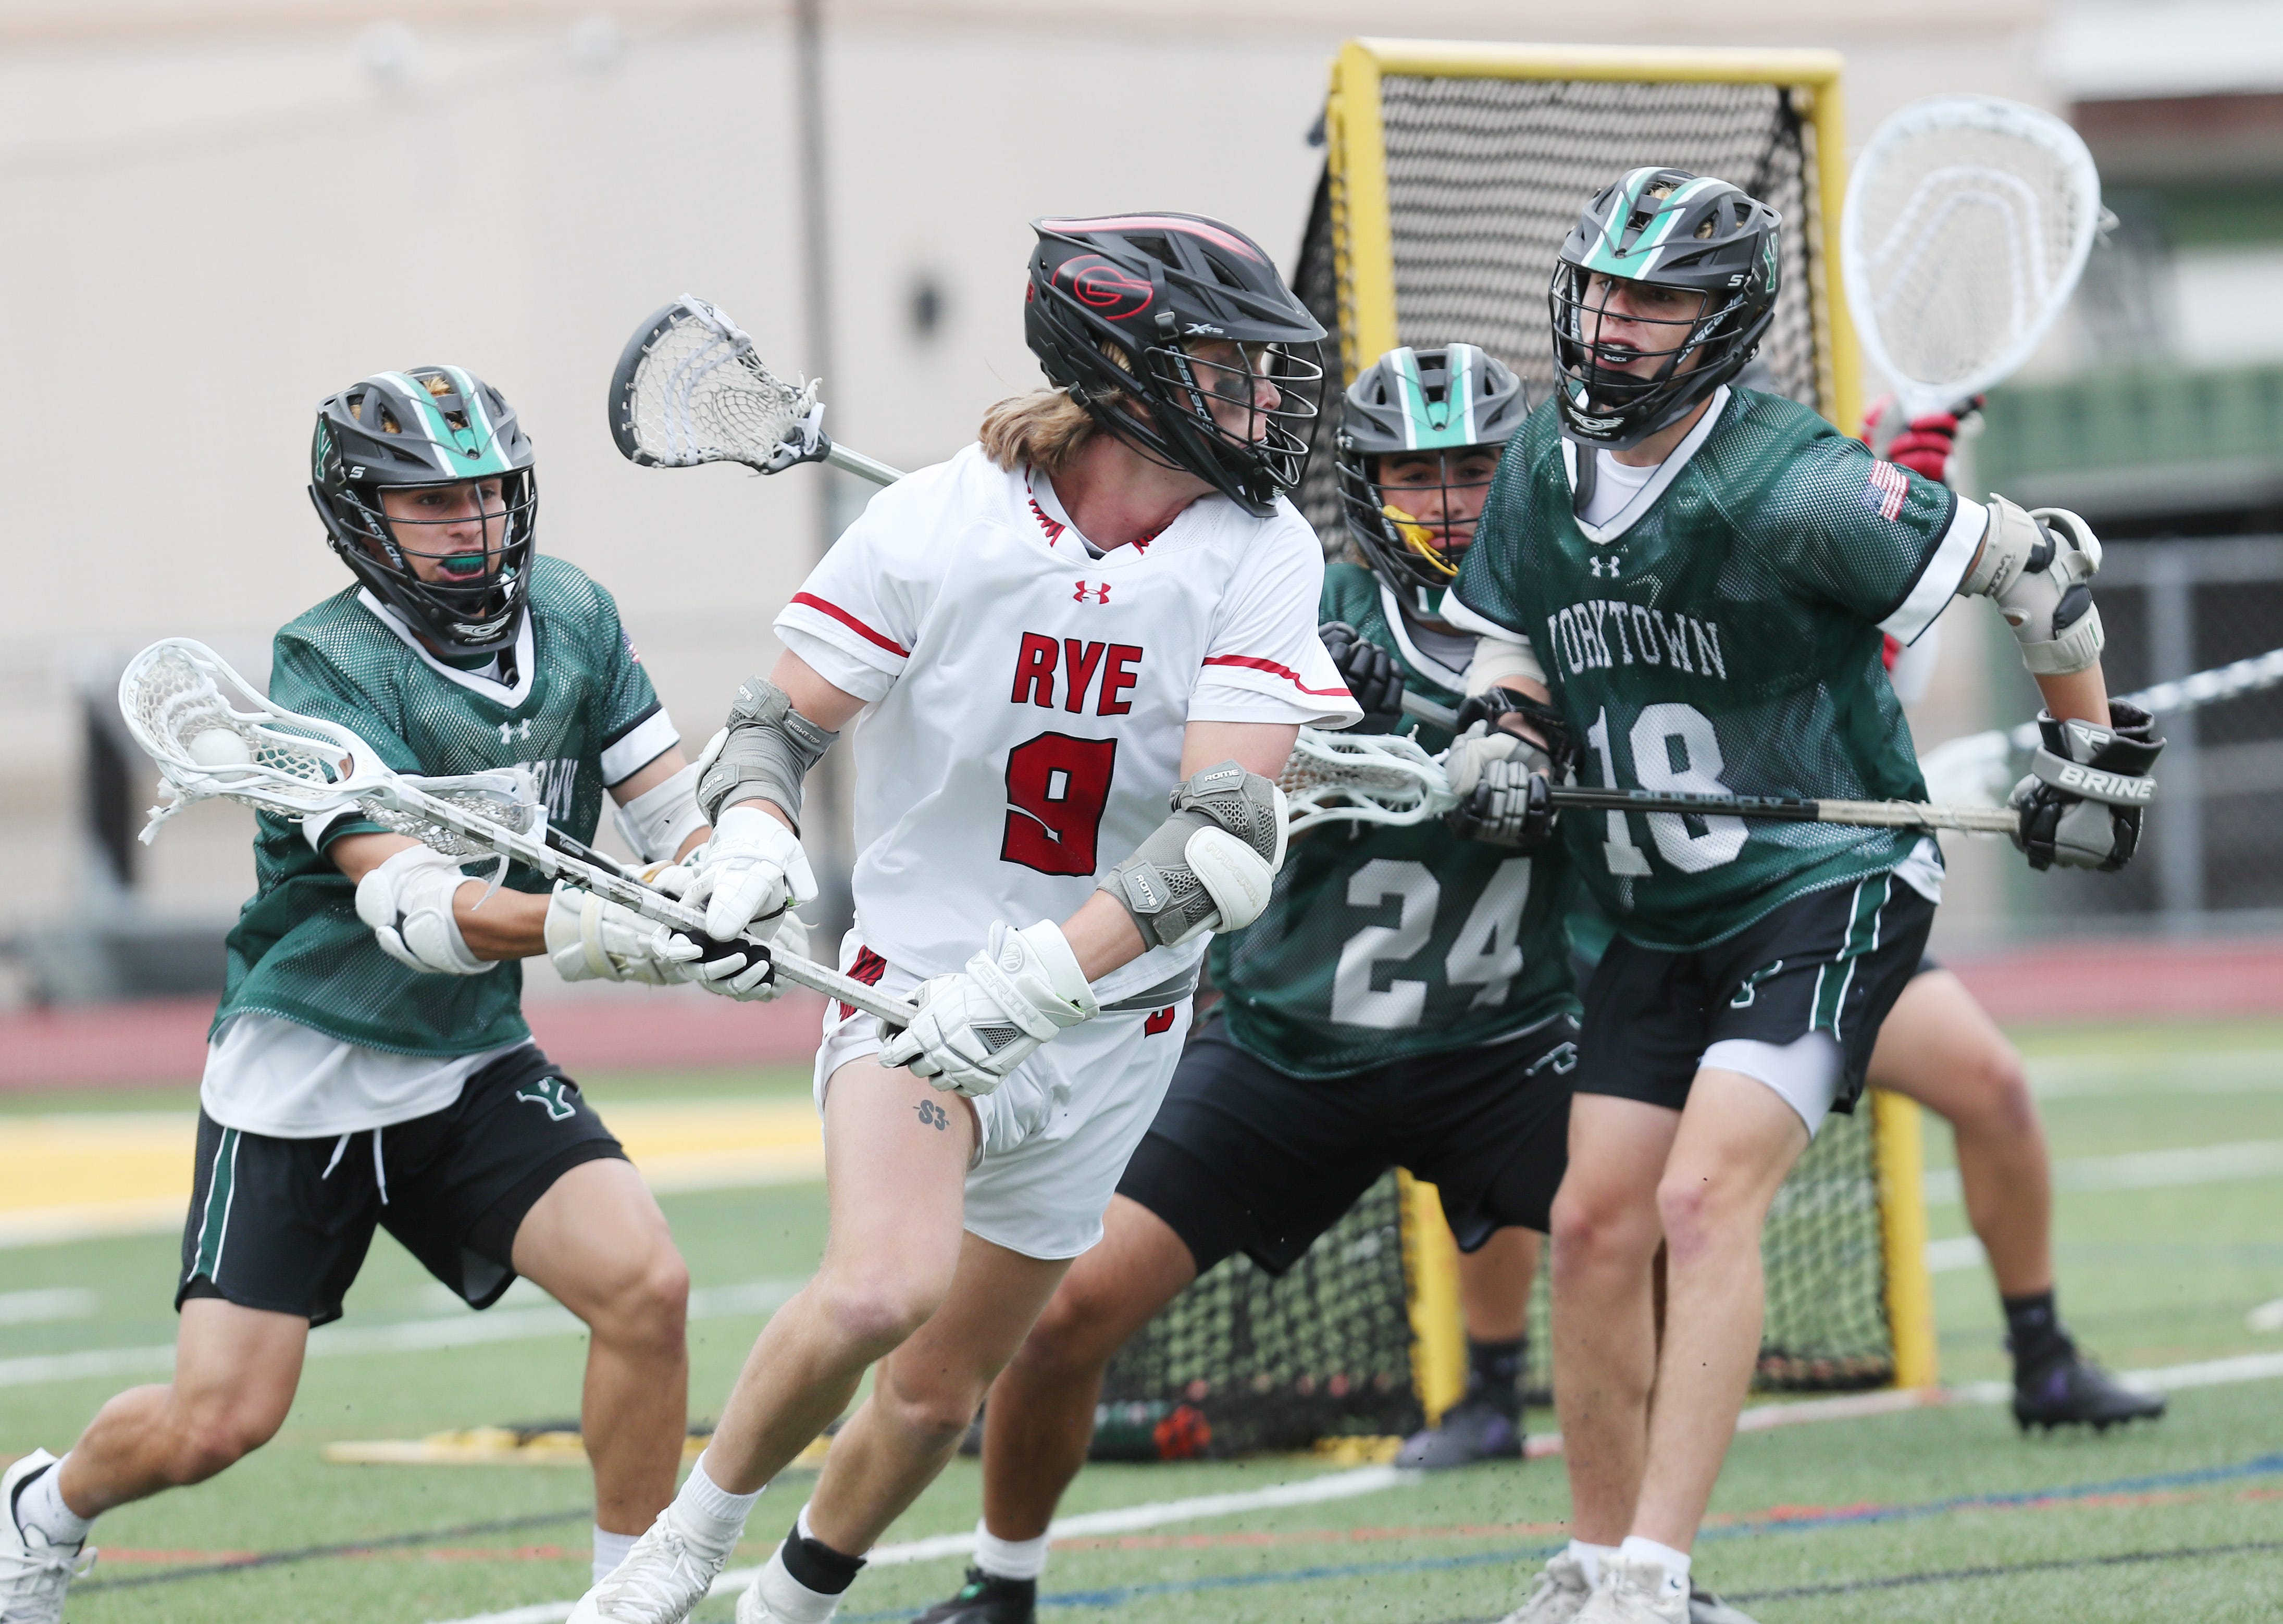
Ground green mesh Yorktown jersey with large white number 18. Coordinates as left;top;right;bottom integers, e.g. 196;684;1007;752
1457;390;1977;951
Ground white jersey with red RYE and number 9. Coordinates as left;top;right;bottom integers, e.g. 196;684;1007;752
776;445;1361;1004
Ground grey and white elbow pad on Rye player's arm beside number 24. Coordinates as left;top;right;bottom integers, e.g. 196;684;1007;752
1100;762;1285;946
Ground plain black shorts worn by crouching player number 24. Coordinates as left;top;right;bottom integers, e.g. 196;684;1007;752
1119;1015;1578;1275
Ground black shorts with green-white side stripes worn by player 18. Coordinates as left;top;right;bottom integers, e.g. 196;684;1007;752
1575;873;1934;1111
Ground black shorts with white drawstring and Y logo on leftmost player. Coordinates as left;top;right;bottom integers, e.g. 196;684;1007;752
173;1045;626;1325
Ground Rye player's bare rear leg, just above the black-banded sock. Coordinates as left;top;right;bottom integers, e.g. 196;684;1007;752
808;1234;1071;1553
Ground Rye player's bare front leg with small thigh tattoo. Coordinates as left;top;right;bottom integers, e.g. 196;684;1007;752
705;1058;975;1494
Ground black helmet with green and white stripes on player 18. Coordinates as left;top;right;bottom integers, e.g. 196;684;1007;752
1548;169;1783;452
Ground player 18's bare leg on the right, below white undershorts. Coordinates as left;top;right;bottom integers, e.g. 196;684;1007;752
1628;1067;1808;1551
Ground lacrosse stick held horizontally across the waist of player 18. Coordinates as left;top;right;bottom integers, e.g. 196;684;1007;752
1281;728;2020;835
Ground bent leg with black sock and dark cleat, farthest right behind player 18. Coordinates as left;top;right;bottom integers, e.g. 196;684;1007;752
1870;969;2164;1428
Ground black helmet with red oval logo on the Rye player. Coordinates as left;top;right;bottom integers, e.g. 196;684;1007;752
1023;215;1324;518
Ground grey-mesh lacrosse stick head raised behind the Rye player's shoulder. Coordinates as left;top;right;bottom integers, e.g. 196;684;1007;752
610;294;904;486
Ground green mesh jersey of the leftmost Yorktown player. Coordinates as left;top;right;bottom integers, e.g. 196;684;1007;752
215;557;676;1056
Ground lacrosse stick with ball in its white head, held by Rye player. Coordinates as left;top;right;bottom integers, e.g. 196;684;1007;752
119;636;918;1027
